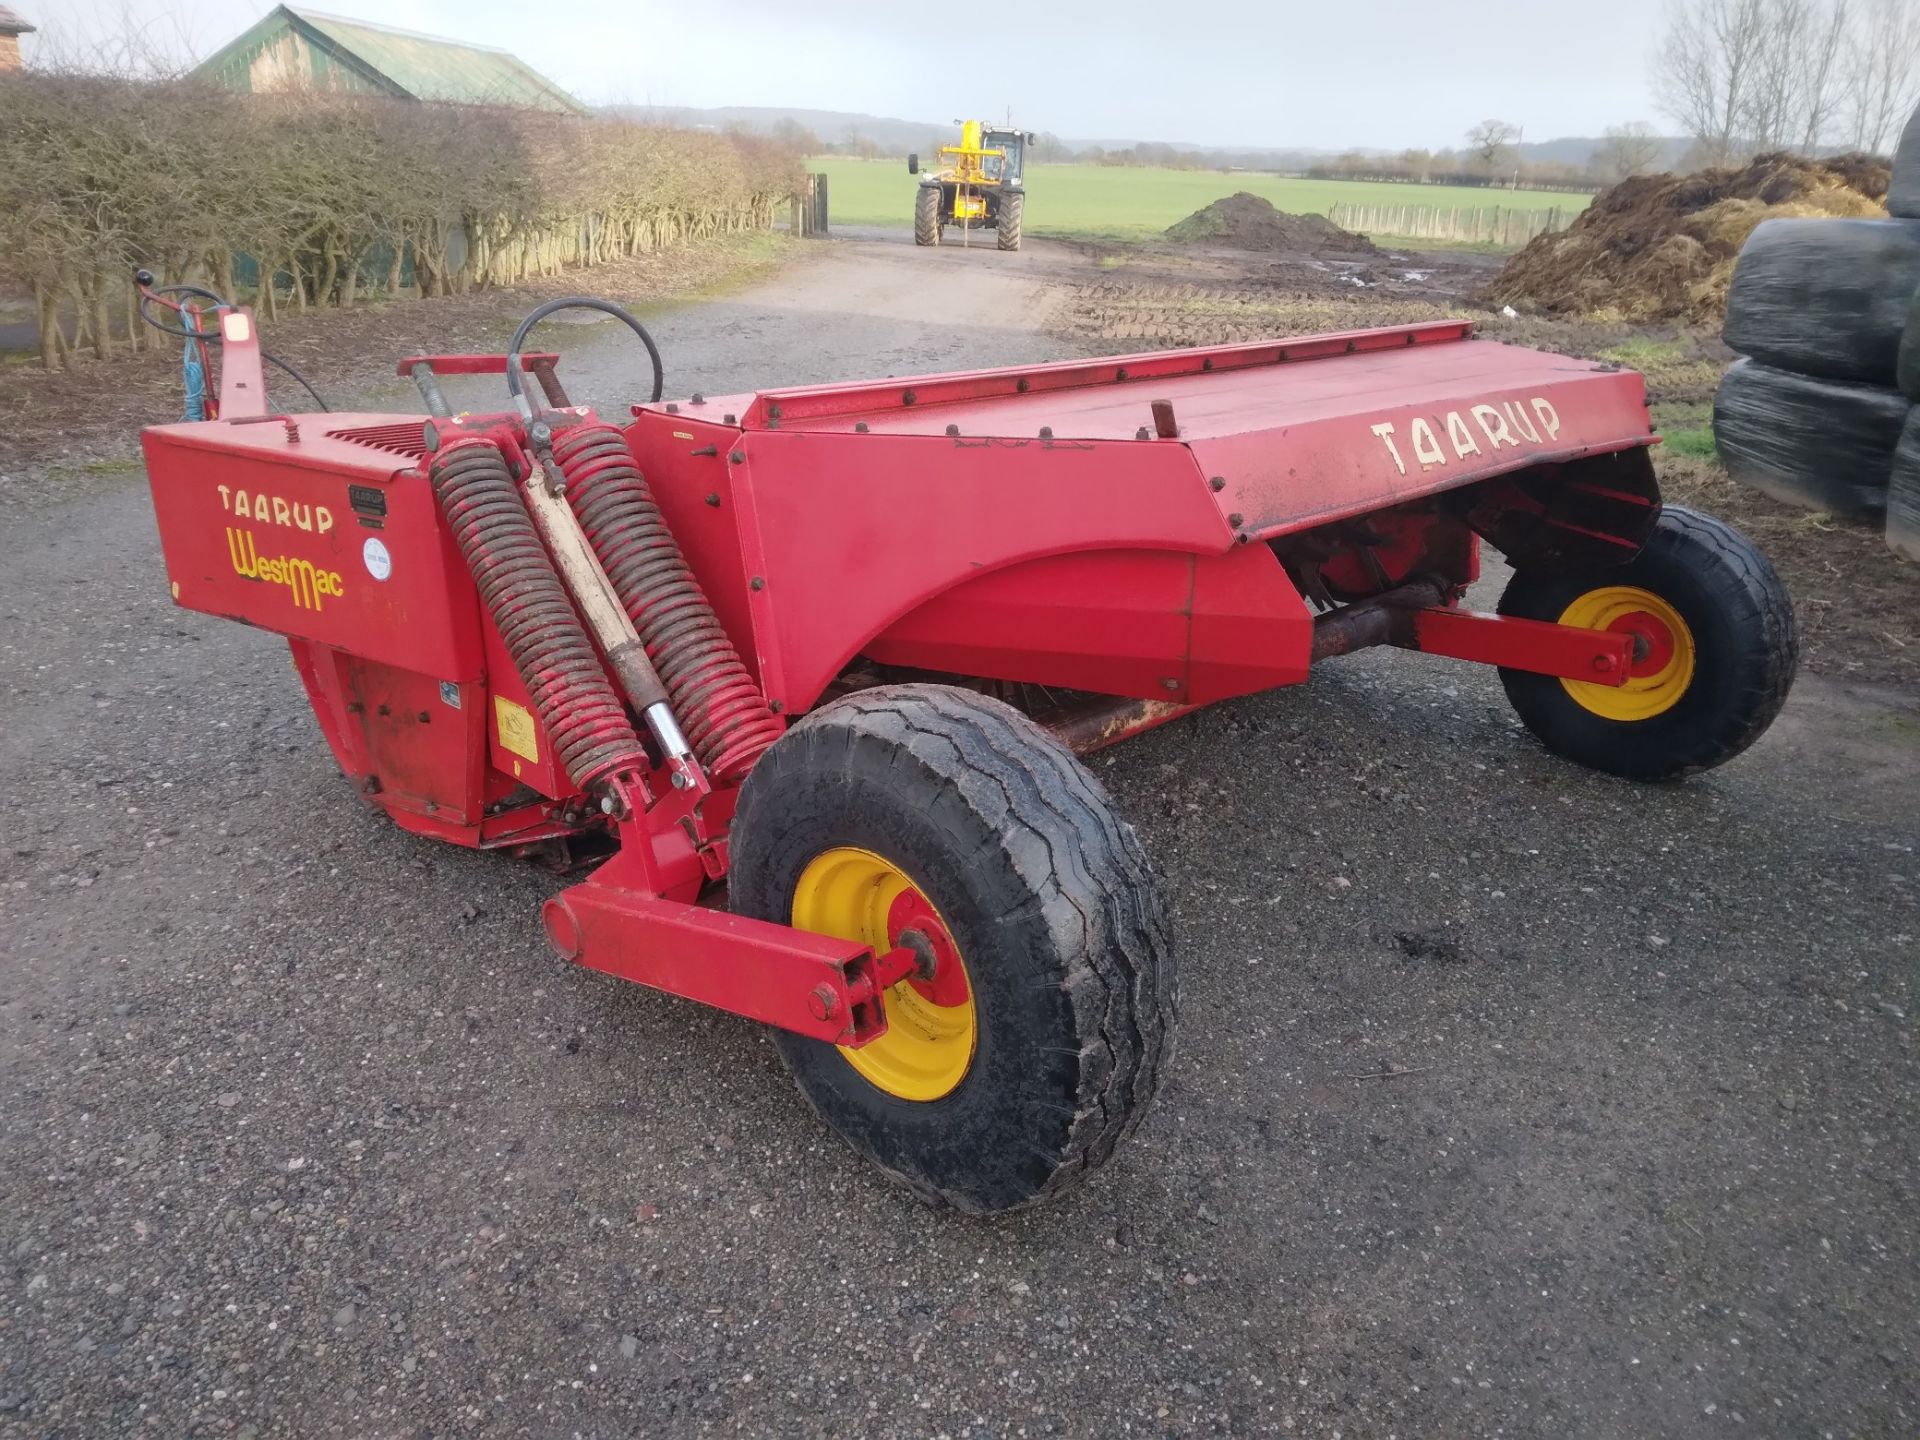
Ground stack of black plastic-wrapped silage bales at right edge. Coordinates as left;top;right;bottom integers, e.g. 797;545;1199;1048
1713;101;1920;559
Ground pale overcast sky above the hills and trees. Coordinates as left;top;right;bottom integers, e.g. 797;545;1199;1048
26;0;1667;148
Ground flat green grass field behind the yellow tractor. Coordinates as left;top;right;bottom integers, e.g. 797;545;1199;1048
806;156;1592;240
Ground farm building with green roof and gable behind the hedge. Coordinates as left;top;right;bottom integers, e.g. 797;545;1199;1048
194;6;588;115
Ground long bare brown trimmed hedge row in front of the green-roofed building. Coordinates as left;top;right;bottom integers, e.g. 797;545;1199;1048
0;73;801;367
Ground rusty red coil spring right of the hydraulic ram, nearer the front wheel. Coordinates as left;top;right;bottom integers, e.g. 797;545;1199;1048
553;420;783;781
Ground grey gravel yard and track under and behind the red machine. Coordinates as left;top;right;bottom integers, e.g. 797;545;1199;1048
0;236;1920;1436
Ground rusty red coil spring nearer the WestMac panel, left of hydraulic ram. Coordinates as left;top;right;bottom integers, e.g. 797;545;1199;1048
426;438;647;802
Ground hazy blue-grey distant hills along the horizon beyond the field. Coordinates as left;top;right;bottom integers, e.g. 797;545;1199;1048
609;106;1688;171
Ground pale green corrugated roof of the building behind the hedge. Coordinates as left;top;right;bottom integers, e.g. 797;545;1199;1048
198;6;589;115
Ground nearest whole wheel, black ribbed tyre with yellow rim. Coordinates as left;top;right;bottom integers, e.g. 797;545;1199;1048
732;685;1177;1212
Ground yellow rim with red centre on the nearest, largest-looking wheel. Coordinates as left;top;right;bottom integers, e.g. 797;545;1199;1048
793;845;979;1100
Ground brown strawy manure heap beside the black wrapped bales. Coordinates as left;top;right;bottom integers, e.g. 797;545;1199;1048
1480;156;1889;323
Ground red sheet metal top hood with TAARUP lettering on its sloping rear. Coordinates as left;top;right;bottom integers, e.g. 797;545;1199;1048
714;321;1653;538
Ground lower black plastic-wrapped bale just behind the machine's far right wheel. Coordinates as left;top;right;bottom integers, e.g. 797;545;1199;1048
1713;361;1908;520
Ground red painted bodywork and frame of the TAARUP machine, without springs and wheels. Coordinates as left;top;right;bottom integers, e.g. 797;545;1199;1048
144;321;1657;1044
